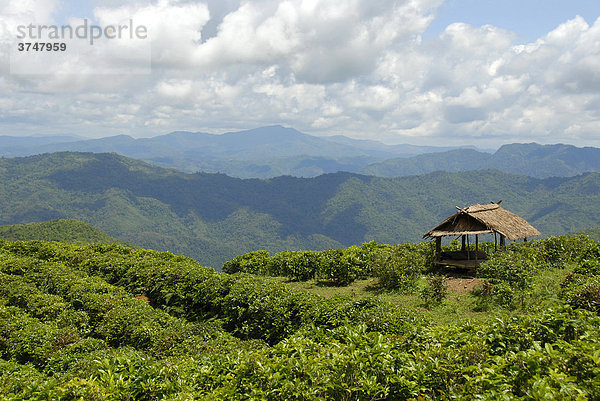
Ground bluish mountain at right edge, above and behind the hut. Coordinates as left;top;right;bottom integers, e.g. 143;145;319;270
360;143;600;178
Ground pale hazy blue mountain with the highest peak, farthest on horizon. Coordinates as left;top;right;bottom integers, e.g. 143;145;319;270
0;126;478;178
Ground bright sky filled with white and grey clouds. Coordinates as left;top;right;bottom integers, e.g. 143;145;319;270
0;0;600;148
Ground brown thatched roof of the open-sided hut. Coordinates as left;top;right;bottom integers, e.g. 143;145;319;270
423;203;540;241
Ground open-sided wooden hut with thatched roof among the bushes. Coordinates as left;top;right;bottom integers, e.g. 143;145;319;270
423;201;540;268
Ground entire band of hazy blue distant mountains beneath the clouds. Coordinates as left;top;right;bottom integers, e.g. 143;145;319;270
0;125;600;178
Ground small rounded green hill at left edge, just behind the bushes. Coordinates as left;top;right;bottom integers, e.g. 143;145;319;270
0;219;122;245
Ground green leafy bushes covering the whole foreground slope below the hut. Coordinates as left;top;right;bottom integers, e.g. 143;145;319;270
0;236;600;400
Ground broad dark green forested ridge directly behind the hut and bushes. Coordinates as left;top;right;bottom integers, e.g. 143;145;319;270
0;153;600;268
